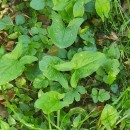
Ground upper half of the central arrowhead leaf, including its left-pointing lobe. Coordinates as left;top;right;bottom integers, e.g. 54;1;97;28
55;51;105;71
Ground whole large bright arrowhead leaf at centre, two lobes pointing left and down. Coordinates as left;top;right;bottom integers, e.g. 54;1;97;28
55;51;106;87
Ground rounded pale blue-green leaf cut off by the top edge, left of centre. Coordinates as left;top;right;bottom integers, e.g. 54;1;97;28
30;0;45;10
